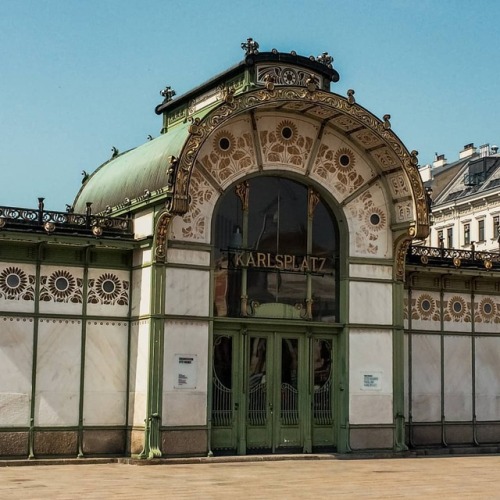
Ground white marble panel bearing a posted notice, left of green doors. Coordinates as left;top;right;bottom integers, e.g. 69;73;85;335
162;321;209;425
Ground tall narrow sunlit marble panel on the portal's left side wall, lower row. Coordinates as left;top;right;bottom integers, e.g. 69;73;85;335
129;320;150;426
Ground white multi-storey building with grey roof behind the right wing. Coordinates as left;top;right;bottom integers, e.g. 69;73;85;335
420;144;500;252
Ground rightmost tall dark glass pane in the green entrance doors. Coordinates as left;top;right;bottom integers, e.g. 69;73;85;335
313;339;333;425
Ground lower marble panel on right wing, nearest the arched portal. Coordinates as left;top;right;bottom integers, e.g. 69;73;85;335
411;334;441;422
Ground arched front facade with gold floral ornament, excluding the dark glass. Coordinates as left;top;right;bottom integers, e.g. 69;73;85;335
149;80;428;453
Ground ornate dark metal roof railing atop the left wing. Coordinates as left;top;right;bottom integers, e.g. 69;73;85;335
0;198;133;238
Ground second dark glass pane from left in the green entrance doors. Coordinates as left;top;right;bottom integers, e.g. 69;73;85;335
248;337;267;425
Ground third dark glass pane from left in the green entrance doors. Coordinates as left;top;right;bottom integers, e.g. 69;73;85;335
280;339;299;425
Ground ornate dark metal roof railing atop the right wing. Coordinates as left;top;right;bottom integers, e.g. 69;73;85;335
406;245;500;271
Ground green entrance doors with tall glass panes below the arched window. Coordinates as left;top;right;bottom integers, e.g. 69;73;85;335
211;327;336;454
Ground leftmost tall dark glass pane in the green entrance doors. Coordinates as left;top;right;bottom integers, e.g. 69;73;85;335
212;335;233;427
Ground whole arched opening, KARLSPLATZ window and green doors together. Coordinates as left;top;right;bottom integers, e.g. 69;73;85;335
210;176;340;454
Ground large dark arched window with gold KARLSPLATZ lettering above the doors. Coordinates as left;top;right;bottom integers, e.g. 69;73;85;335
214;176;339;322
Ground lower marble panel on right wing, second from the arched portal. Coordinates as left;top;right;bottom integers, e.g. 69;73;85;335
444;336;472;421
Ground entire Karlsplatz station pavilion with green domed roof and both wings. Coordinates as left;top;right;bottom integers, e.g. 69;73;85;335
0;39;500;458
